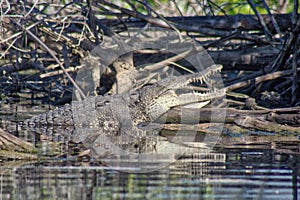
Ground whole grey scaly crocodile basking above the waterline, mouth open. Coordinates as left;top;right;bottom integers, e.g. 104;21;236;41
25;65;225;128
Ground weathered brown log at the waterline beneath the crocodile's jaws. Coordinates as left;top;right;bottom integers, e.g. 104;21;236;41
162;107;300;134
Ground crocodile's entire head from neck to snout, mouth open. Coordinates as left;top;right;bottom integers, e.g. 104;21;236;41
134;65;225;121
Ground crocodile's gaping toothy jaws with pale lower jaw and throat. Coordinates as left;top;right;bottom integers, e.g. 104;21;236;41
146;65;225;120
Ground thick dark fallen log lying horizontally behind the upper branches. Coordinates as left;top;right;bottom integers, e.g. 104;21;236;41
100;13;299;34
